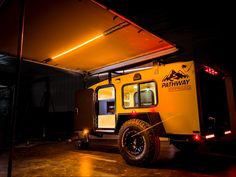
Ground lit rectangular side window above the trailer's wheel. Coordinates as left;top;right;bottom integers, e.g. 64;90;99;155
123;82;157;108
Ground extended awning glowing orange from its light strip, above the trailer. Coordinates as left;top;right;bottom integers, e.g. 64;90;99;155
0;0;177;74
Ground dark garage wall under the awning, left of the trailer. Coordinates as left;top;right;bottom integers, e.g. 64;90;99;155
0;56;83;149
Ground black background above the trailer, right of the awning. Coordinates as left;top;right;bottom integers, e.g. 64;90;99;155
97;0;236;75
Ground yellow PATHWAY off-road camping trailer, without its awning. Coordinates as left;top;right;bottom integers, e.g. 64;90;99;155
75;61;234;165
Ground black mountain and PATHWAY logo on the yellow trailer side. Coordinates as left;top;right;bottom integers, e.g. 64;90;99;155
162;65;192;92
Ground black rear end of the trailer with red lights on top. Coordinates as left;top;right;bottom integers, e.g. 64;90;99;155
198;65;230;139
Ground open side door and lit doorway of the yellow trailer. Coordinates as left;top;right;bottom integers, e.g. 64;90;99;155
74;85;116;133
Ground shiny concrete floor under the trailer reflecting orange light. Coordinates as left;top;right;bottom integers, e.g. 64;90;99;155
0;141;236;177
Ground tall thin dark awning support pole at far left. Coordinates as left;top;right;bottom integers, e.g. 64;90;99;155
7;0;25;177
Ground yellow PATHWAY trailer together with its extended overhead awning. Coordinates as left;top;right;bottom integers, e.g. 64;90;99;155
0;0;232;168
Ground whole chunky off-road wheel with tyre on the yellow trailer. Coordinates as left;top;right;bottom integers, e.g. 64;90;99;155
118;119;160;166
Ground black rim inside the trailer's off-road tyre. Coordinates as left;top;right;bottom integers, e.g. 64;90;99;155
123;130;145;156
